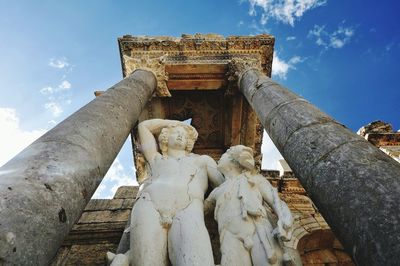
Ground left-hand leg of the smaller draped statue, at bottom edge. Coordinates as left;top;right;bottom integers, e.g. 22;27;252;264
221;230;252;266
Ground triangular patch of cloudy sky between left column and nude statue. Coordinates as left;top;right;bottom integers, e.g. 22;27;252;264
92;157;138;199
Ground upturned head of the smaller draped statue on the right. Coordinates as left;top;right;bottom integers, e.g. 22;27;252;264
218;145;254;176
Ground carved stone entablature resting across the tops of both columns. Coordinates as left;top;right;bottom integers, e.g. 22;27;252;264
118;34;275;96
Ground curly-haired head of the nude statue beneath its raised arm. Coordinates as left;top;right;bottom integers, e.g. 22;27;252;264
158;124;198;156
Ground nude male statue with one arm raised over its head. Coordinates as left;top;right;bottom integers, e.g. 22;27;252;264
129;119;223;266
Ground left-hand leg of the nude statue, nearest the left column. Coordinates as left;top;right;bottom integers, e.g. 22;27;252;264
130;193;168;266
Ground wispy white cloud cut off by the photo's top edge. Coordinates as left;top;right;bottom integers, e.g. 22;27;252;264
248;0;327;27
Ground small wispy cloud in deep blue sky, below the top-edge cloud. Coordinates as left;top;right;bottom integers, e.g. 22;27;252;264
308;23;355;50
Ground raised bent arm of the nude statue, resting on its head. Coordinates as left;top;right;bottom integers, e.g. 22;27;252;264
138;119;181;162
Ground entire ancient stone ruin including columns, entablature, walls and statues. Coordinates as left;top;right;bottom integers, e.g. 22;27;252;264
0;34;400;265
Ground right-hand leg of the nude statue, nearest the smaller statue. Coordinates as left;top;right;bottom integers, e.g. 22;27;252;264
168;199;214;266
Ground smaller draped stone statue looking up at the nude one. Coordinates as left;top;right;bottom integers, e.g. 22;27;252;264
205;145;301;266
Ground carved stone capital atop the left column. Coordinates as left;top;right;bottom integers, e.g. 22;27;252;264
124;55;171;97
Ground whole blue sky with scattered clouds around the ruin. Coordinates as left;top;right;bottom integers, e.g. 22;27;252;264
0;0;400;197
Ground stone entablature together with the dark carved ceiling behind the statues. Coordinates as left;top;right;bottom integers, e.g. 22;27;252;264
118;34;275;182
